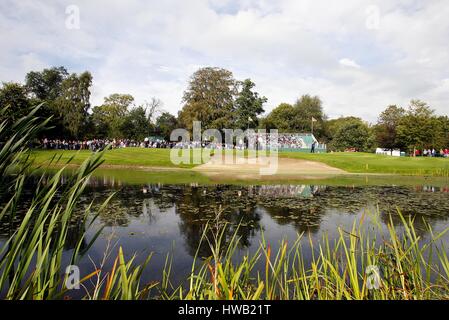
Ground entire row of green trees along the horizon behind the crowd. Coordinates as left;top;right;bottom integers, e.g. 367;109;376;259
0;67;449;152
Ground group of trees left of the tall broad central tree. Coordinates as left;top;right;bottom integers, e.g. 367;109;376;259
0;67;177;140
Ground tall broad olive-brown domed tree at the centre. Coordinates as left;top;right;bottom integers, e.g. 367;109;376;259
178;67;237;130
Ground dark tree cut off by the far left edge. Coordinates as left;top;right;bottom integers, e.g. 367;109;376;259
0;82;30;123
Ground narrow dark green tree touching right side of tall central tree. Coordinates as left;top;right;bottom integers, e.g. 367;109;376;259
235;79;267;130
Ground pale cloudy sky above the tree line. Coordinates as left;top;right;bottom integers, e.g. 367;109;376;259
0;0;449;121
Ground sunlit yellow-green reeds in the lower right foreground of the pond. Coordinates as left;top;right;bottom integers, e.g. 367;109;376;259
168;211;449;300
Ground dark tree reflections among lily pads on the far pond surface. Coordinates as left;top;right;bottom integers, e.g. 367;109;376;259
80;183;449;251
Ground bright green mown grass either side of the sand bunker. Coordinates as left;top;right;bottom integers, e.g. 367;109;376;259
31;148;449;177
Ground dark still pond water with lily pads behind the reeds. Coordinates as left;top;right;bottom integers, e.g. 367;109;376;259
0;177;449;296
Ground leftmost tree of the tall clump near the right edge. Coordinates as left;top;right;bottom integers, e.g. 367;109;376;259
374;105;405;151
